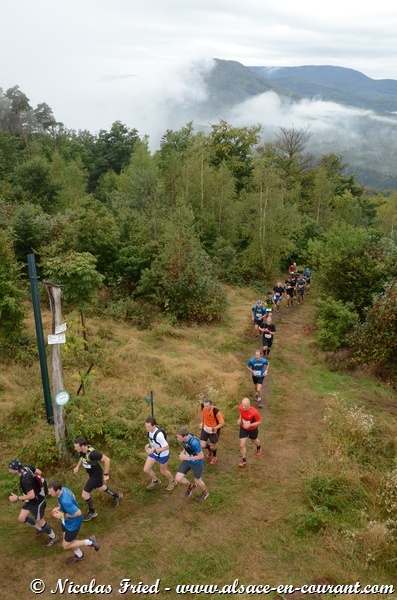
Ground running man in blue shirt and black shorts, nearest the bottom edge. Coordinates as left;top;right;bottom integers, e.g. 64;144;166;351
48;480;100;563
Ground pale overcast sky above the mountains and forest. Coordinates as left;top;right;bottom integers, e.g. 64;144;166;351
0;0;397;148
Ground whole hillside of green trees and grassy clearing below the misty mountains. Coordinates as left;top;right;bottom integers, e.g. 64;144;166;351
0;83;397;597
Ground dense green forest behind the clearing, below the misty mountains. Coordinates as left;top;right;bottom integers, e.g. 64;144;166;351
0;86;397;376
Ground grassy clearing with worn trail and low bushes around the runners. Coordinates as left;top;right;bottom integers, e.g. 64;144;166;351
0;290;397;599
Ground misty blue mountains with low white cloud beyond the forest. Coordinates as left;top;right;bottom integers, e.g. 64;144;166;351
190;59;397;190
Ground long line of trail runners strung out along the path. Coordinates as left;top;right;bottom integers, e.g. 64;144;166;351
8;263;311;563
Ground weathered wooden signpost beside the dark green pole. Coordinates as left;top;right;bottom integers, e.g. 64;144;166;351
43;281;69;460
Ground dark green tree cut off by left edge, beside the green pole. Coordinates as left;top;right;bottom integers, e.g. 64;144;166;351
0;230;26;343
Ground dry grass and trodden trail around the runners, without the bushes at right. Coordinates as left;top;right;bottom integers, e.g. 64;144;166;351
0;290;397;600
